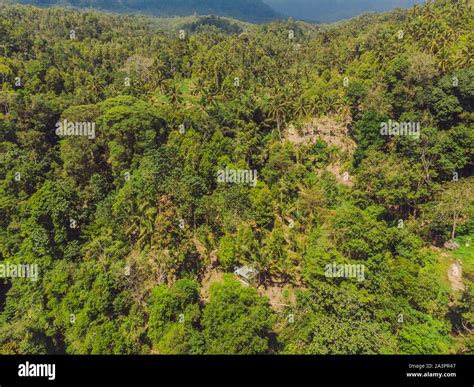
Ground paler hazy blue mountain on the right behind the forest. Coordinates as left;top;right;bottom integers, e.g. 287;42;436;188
264;0;424;22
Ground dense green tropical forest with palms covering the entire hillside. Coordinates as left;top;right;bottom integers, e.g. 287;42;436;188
0;0;474;354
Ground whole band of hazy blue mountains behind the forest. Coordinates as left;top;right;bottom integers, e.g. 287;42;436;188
6;0;430;23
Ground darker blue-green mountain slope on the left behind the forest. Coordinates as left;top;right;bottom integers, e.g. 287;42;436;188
12;0;282;22
